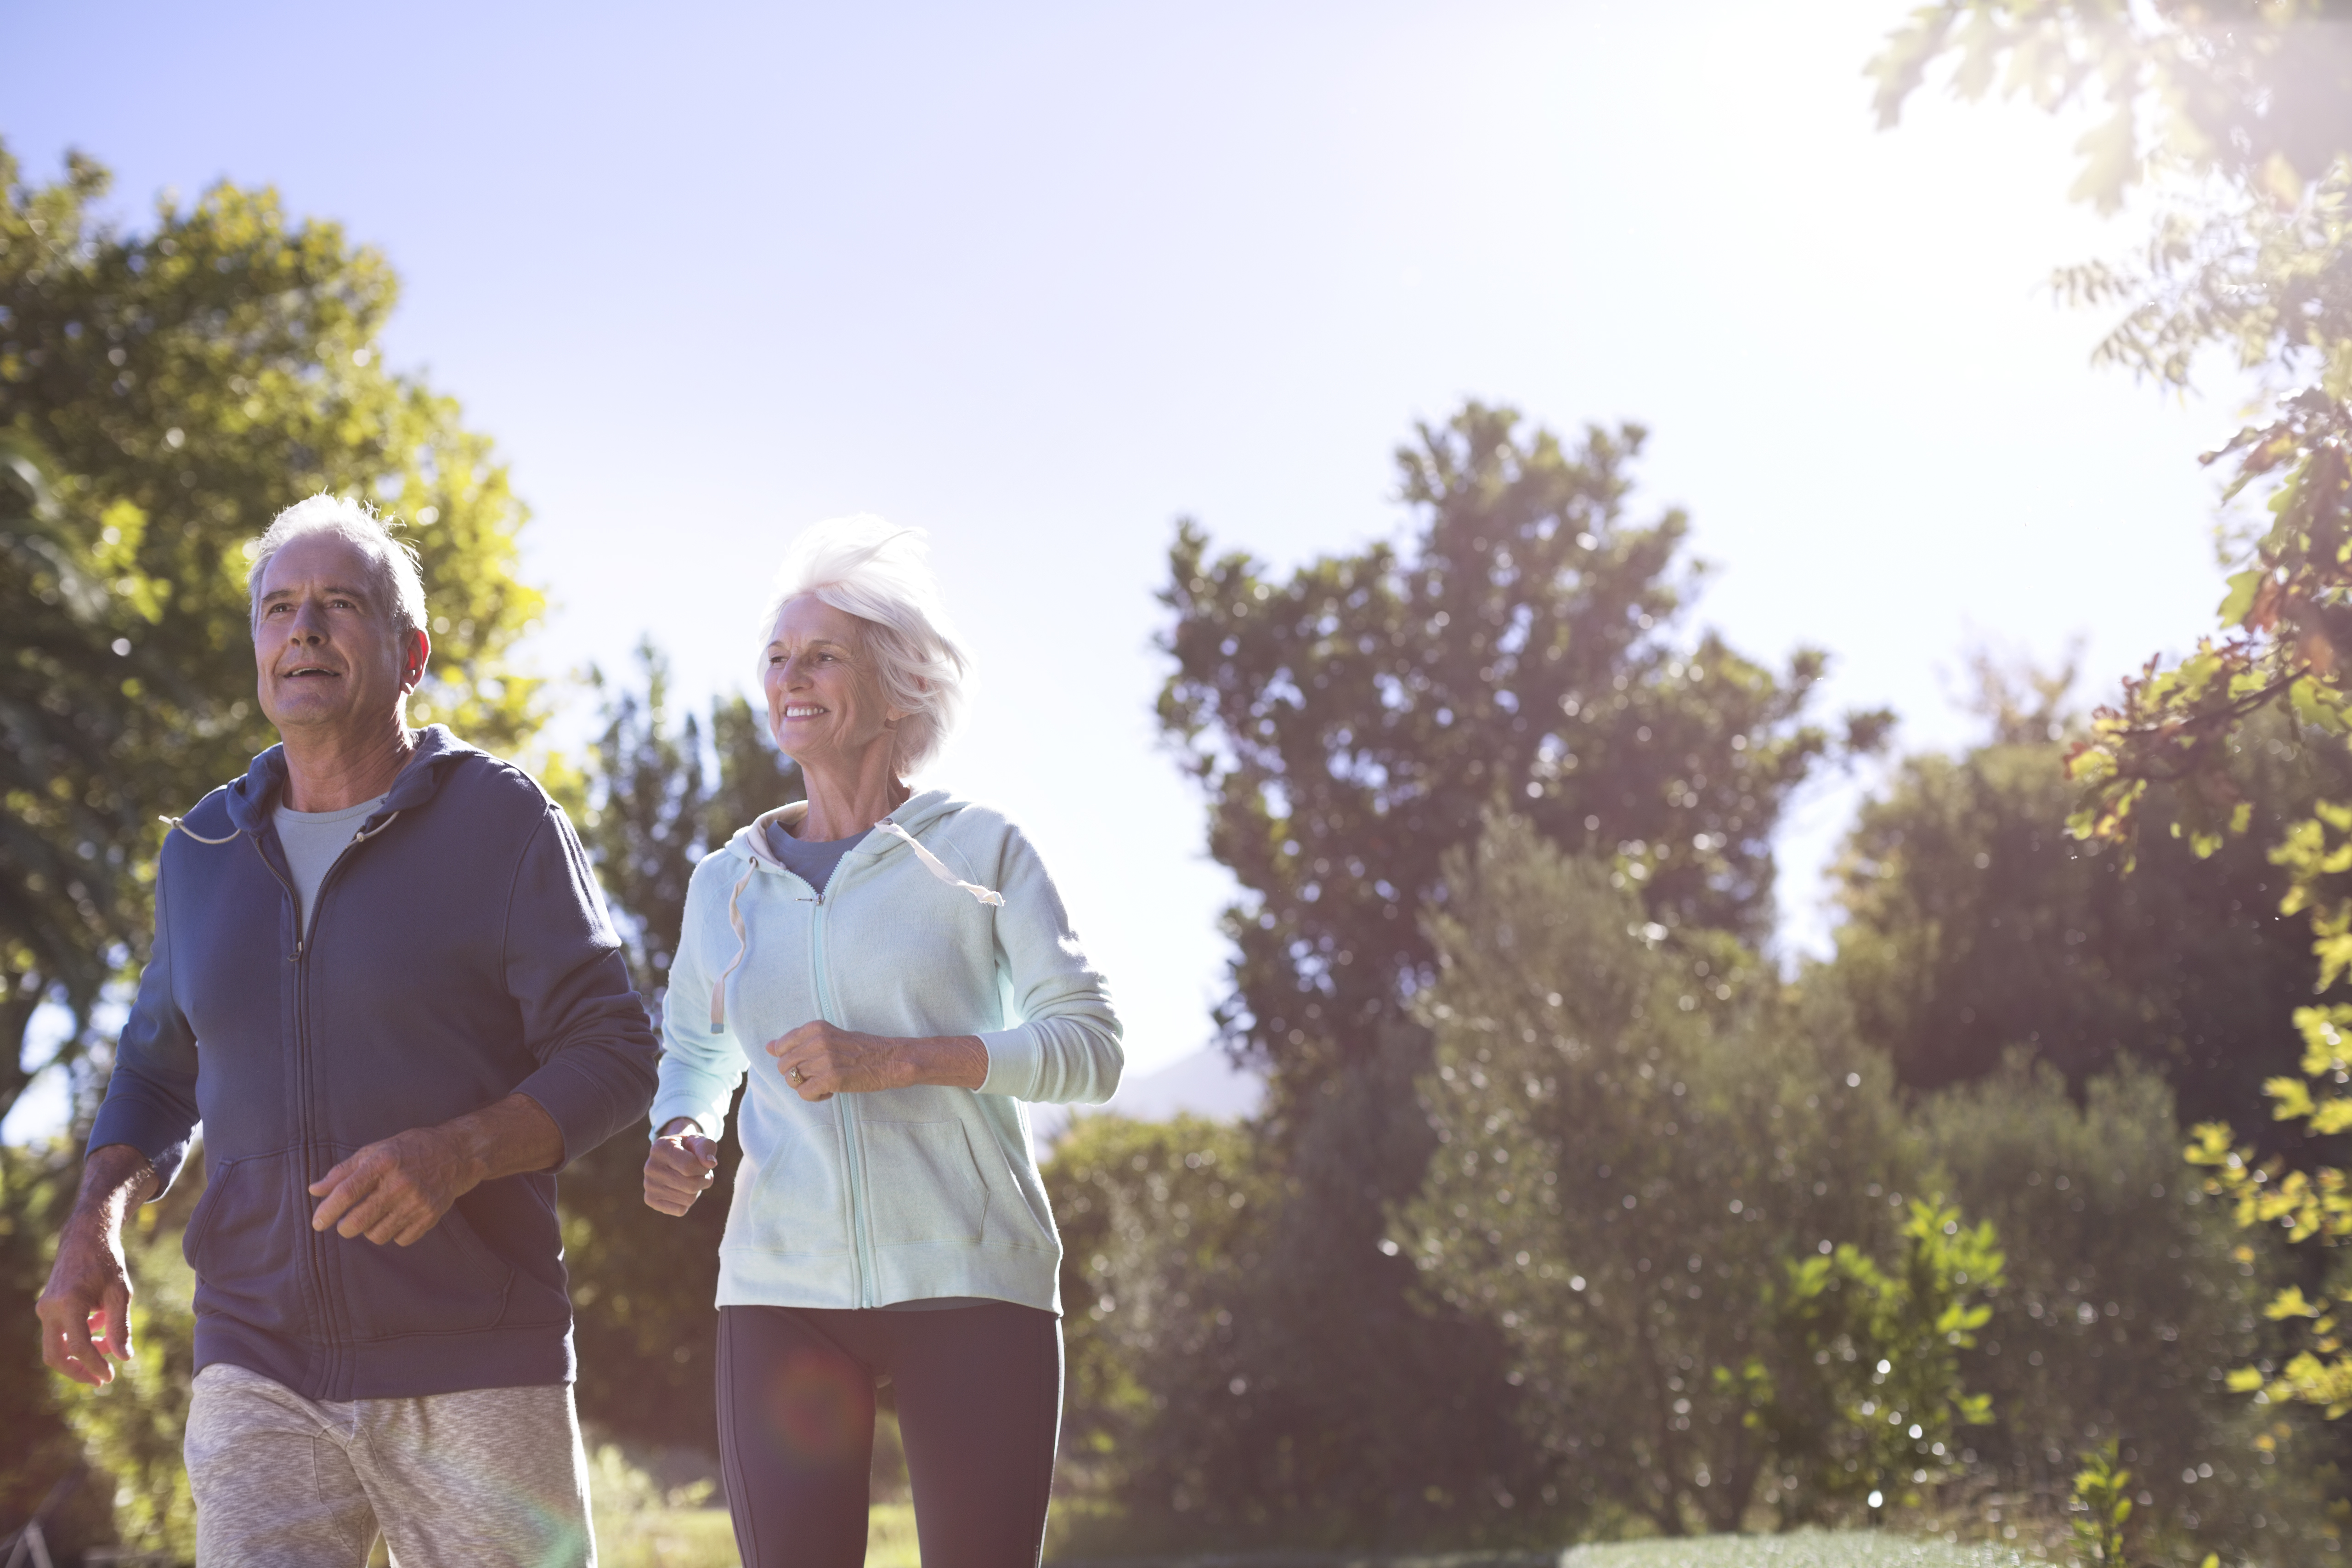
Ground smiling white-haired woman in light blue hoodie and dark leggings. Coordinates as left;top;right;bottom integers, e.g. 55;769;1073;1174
645;517;1124;1568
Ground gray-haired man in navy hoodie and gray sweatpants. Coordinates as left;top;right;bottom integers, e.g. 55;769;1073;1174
40;496;659;1568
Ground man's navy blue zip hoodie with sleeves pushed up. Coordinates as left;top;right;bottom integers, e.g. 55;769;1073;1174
90;724;659;1399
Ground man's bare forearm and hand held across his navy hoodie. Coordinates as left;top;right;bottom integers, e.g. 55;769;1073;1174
311;1095;565;1246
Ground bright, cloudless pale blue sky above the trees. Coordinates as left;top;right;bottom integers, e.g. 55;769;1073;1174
0;0;2237;1104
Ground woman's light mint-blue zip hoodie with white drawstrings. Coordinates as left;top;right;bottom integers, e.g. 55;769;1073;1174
651;790;1126;1314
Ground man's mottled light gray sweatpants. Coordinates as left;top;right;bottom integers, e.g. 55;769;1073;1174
186;1364;595;1568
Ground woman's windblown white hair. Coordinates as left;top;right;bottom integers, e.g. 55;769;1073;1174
760;512;972;776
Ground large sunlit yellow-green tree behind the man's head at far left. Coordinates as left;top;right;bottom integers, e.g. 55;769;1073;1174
0;146;541;1114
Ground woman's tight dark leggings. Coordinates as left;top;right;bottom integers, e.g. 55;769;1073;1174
720;1302;1061;1568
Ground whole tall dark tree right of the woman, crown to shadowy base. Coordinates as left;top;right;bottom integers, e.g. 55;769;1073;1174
1159;404;1884;1545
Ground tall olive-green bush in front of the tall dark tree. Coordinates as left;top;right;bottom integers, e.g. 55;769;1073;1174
1388;818;1907;1535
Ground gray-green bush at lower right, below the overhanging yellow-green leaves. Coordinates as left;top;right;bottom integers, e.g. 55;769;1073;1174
1919;1060;2335;1561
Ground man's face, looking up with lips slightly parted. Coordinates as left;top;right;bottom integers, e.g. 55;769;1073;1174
254;534;428;733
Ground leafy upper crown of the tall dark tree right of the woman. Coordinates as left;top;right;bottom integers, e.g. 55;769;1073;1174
1159;402;1886;1107
